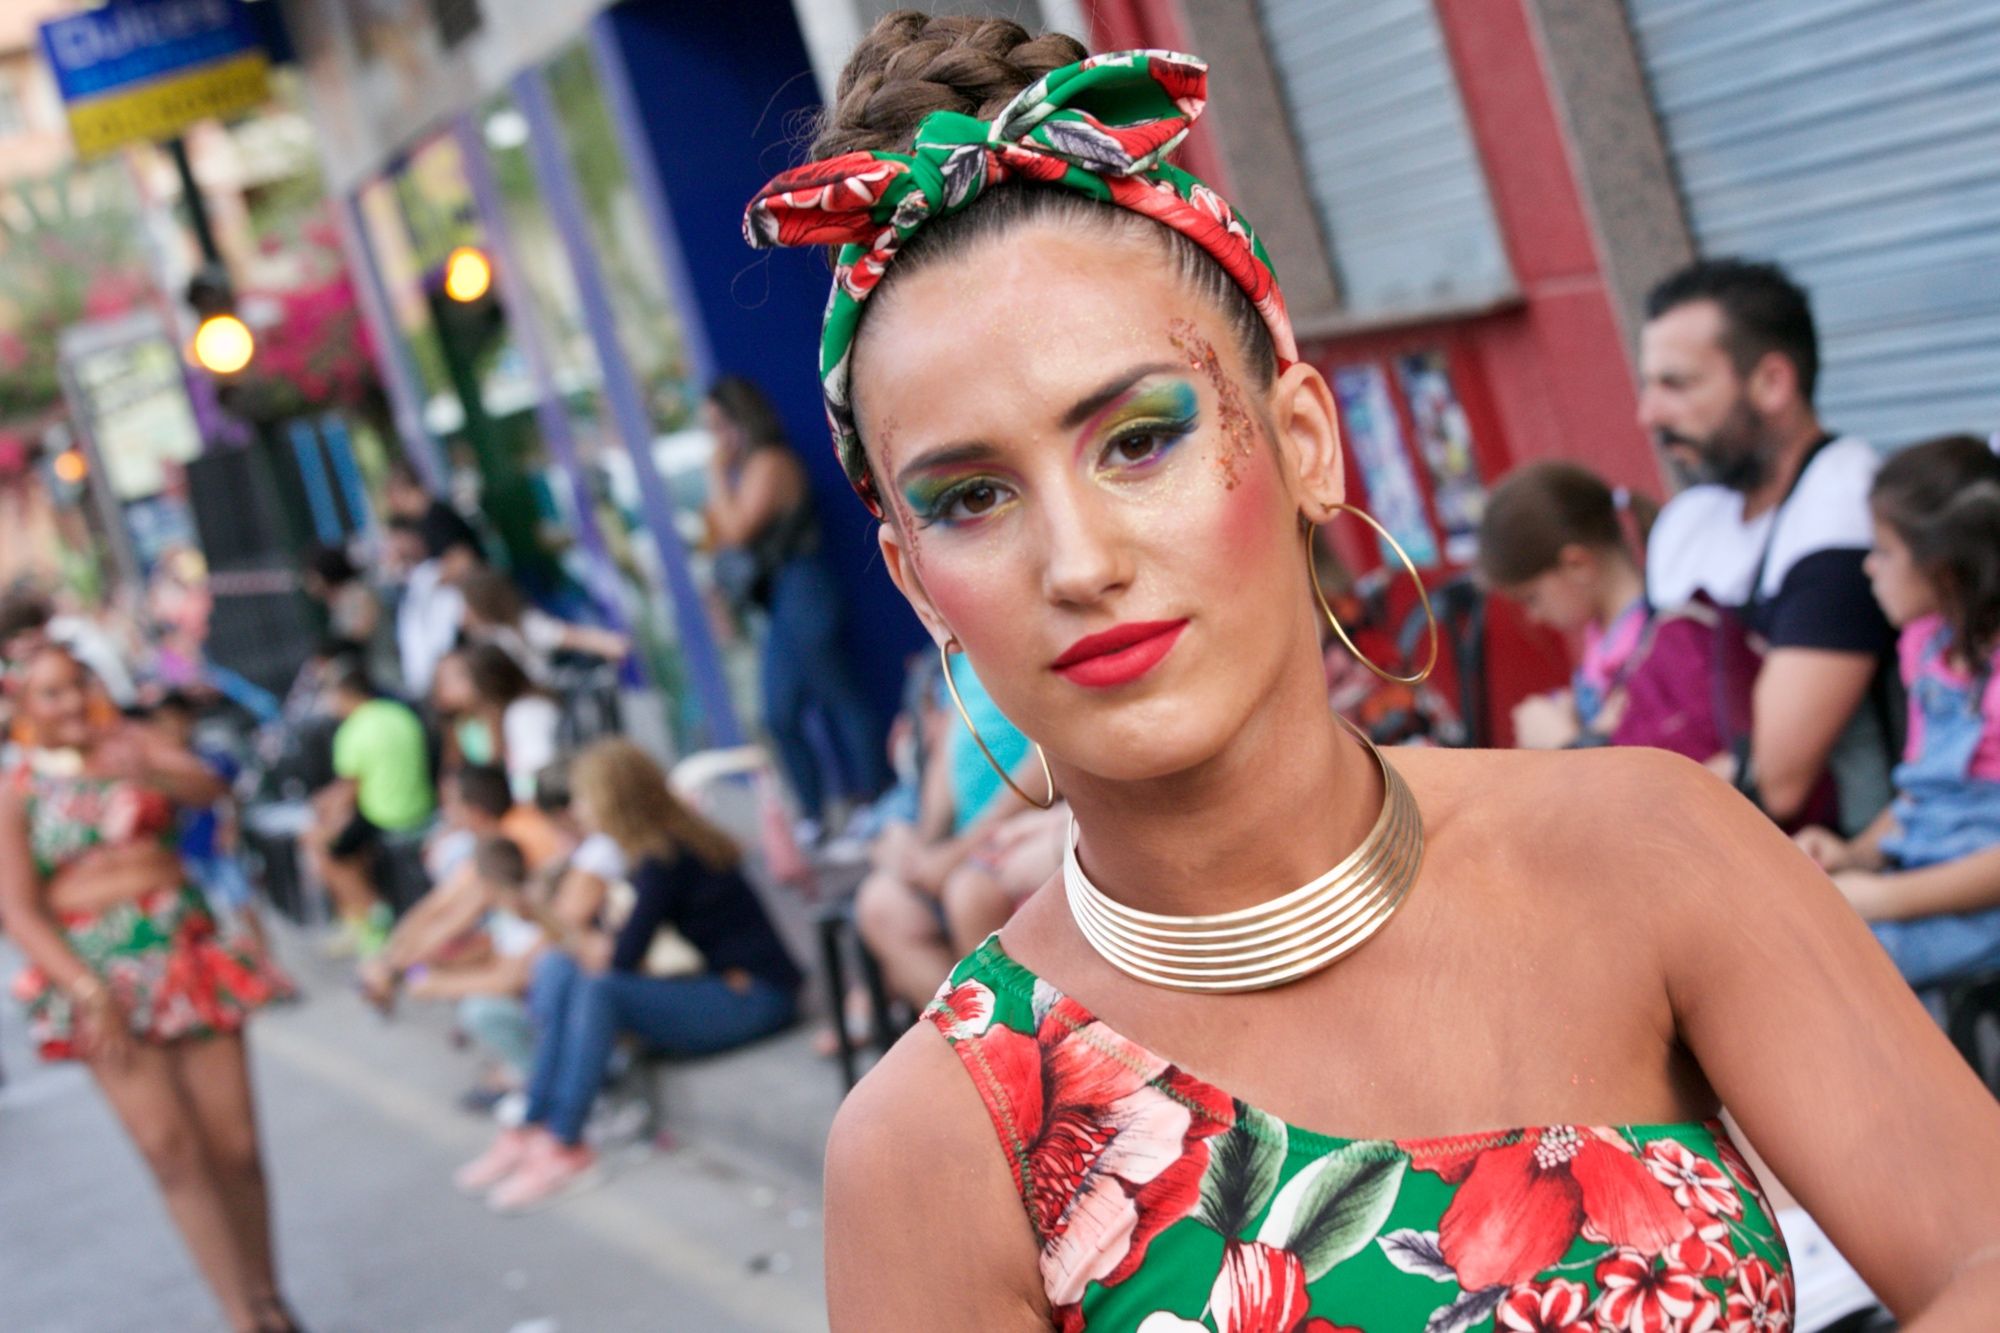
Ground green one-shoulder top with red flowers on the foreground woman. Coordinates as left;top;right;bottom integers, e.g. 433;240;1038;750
924;937;1792;1333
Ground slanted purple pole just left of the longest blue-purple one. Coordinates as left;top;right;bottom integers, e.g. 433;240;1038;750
452;114;628;630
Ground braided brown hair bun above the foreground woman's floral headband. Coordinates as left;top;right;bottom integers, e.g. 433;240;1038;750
812;10;1088;158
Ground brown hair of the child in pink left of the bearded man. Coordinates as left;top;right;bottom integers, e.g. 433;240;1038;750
1478;460;1660;588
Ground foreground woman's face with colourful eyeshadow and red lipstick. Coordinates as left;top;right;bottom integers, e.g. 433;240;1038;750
854;224;1340;781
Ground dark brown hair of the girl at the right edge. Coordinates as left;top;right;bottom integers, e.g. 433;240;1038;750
1868;434;2000;681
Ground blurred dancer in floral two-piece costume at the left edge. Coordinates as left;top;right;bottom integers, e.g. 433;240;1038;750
0;642;296;1333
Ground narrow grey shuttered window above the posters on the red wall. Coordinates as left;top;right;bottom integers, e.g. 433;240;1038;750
1258;0;1514;318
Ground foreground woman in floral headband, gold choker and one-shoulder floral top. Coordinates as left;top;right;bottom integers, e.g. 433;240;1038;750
746;12;2000;1333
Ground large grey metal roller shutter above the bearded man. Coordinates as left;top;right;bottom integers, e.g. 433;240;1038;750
1628;0;2000;444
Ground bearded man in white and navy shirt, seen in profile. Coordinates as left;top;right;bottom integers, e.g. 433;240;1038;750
1638;258;1896;831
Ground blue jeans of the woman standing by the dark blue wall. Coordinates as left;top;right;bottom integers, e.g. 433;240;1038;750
762;556;888;819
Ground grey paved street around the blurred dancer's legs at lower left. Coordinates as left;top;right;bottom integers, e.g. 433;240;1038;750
0;932;838;1333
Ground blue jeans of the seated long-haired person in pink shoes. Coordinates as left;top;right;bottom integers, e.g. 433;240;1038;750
528;953;798;1145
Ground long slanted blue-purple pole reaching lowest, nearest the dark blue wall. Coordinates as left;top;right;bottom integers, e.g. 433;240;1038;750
510;68;742;747
